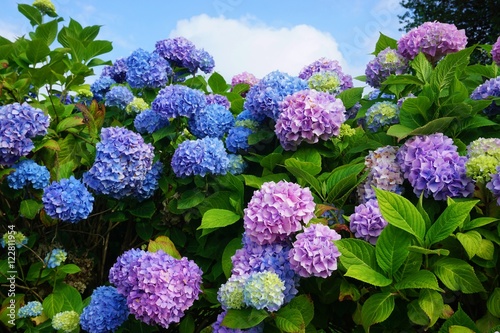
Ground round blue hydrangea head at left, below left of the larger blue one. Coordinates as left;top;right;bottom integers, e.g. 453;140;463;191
42;176;94;223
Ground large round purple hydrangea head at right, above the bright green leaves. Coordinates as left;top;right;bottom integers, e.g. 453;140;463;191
397;133;474;200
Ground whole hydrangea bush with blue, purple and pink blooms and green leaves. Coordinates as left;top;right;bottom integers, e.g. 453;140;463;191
0;0;500;333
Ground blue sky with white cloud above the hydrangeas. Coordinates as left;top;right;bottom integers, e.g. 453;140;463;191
0;0;404;86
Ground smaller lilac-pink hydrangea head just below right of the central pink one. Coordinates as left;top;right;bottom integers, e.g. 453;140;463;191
288;224;340;278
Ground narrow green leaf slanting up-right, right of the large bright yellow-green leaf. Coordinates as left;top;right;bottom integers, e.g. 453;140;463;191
425;200;479;247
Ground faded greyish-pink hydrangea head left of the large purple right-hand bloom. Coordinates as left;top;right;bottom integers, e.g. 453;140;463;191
358;146;404;203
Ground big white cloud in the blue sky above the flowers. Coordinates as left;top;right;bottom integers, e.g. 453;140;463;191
170;14;347;81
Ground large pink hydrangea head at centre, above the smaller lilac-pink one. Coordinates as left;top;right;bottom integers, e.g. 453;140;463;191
243;181;316;244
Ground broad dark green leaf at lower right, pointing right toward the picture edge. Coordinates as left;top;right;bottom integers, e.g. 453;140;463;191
433;258;484;294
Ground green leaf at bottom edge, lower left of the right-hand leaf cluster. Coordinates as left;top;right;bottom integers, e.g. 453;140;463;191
361;293;394;332
